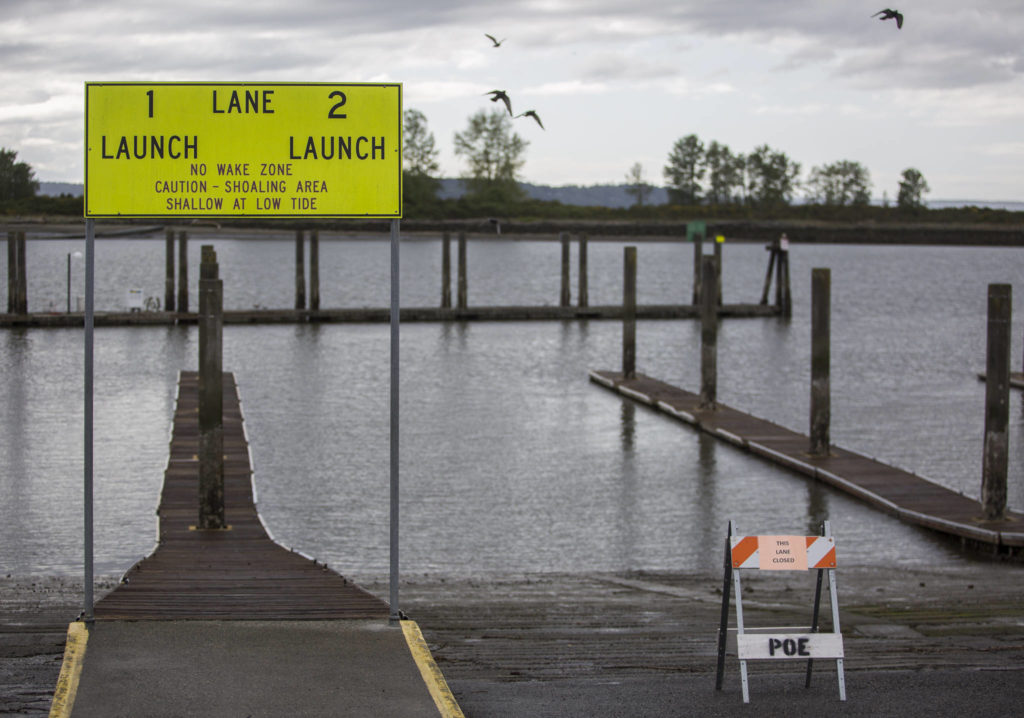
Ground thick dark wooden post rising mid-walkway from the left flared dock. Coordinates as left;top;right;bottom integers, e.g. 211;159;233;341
197;245;226;529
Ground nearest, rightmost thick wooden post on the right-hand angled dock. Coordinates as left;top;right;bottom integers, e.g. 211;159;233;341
981;284;1013;520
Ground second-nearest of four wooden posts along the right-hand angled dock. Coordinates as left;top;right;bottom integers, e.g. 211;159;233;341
810;267;831;456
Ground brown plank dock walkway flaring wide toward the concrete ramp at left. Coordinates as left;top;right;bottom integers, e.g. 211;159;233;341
95;372;388;621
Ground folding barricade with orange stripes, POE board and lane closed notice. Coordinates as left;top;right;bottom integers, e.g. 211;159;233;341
715;521;846;703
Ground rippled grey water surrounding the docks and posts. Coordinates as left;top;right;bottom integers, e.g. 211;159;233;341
0;235;1024;578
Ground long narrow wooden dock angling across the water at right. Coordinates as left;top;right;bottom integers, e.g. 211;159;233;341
590;371;1024;555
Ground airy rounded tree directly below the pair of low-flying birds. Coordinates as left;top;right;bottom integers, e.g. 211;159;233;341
455;110;529;202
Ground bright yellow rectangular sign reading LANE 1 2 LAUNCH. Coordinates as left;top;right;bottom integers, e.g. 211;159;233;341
85;82;402;217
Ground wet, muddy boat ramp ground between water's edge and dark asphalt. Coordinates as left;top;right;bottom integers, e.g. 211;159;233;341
6;561;1024;716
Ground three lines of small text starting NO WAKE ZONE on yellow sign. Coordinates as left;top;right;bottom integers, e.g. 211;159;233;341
153;162;329;211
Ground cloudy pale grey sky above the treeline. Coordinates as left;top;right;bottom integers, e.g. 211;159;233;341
0;0;1024;201
